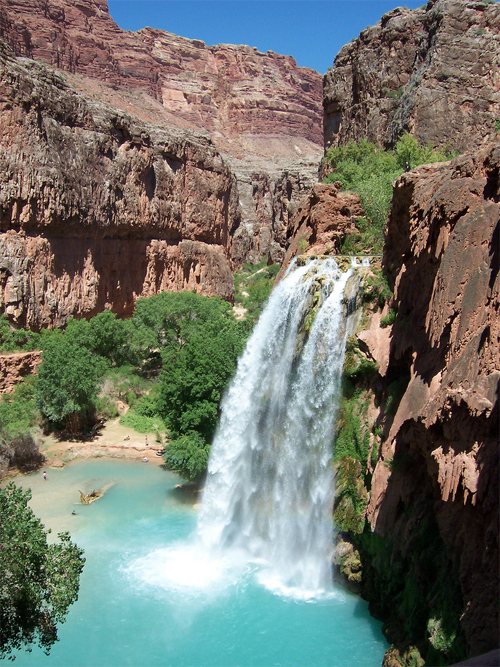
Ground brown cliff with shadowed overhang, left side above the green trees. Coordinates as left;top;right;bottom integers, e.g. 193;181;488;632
0;43;239;328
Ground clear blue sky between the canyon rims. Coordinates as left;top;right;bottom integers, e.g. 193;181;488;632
108;0;424;74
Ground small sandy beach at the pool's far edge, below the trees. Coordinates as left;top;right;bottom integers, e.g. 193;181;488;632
41;418;164;468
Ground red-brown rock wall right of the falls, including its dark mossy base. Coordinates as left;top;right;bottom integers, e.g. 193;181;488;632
338;142;500;664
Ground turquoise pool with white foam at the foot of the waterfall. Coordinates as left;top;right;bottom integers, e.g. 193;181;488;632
3;460;387;667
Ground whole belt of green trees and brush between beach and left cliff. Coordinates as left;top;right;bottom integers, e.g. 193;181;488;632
0;294;250;480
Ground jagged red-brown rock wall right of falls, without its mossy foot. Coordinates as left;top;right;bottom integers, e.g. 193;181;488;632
367;143;500;655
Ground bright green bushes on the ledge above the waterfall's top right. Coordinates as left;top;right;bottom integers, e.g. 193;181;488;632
325;134;453;254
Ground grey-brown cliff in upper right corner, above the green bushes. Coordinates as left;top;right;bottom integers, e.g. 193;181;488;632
324;0;500;150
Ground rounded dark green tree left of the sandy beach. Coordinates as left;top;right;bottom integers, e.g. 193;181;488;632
36;328;107;434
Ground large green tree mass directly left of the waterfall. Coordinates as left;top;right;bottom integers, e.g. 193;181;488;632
148;292;248;479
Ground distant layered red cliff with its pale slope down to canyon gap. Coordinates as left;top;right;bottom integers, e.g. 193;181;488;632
0;0;323;263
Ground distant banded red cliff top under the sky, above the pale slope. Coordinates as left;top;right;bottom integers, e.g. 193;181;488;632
0;0;323;145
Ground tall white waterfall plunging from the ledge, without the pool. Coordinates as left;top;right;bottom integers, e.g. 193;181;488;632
198;259;351;596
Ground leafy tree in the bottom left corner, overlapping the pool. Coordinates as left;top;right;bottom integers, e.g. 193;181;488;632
0;482;85;658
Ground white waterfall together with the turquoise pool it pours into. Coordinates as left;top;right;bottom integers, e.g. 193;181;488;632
2;262;387;667
